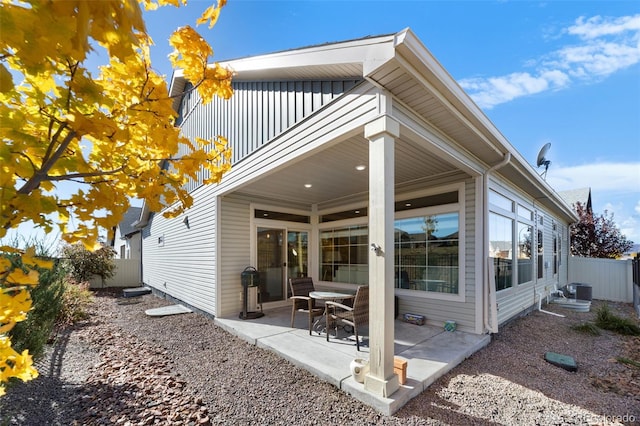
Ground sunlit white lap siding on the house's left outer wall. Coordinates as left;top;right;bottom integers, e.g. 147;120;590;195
143;188;216;314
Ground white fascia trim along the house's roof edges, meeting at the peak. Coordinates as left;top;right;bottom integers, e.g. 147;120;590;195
164;28;574;223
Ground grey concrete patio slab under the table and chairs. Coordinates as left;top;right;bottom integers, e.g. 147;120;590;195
215;306;491;415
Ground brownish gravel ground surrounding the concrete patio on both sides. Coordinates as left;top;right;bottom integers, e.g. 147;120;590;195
0;291;640;425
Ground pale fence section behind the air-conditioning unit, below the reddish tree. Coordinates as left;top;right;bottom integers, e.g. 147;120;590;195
568;257;634;303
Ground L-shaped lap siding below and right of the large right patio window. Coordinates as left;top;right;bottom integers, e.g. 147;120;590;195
400;179;482;332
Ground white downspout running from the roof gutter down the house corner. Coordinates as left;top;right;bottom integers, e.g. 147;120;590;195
482;152;511;333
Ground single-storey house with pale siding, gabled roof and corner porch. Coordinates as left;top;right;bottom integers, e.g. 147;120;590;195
139;29;576;395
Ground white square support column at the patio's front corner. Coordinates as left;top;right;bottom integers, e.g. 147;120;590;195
364;115;400;397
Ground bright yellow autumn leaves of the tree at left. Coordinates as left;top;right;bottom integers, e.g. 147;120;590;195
0;0;233;392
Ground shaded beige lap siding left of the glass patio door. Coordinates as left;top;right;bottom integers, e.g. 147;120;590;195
218;197;251;317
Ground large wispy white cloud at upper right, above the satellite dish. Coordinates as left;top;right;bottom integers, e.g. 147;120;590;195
459;14;640;109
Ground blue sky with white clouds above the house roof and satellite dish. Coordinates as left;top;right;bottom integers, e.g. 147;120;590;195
141;0;640;243
